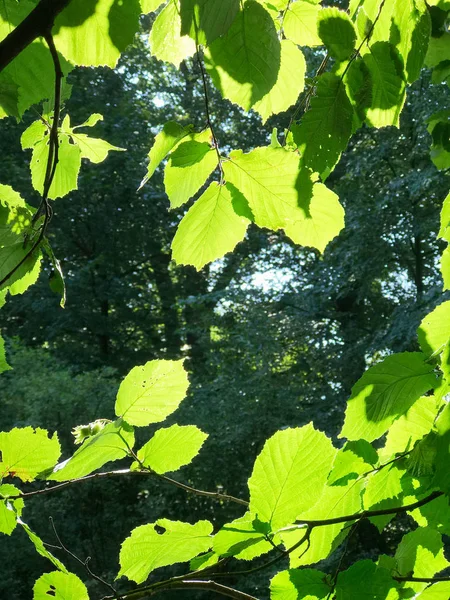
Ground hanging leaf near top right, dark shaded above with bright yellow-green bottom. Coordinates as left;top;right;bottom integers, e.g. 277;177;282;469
363;42;405;127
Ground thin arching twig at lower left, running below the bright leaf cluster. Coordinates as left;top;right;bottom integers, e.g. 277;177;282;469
4;469;248;506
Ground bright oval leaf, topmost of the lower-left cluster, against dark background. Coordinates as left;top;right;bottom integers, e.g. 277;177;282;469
115;360;189;426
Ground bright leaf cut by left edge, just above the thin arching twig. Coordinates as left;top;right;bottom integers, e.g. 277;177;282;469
0;427;61;481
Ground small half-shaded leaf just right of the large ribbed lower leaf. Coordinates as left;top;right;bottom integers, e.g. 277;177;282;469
328;440;378;485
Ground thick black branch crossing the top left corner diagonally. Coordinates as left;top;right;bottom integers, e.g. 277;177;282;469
0;0;71;72
